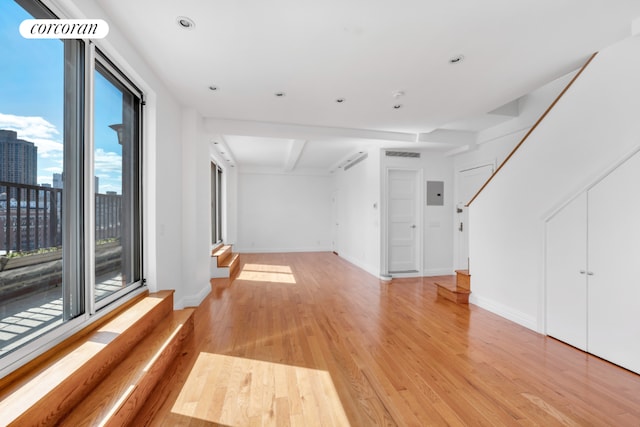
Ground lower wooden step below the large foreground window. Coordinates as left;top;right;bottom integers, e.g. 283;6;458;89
63;309;194;426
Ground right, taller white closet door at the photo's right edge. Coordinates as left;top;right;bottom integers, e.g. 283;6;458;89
587;154;640;373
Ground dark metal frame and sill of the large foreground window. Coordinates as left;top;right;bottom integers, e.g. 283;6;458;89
0;0;147;378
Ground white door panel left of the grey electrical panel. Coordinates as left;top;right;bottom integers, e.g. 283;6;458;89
388;170;422;273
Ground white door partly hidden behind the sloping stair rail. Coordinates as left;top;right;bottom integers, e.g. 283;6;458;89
455;165;493;270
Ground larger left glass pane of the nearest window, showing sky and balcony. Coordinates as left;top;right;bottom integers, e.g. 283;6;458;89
0;1;65;357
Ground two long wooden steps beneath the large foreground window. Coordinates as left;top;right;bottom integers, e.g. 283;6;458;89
0;291;194;426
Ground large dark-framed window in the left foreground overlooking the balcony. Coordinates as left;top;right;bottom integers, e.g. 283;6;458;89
0;0;143;376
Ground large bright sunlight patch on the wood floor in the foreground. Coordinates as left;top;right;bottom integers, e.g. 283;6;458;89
171;352;349;427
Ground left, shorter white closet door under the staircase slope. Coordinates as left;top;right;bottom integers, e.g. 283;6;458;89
546;193;587;350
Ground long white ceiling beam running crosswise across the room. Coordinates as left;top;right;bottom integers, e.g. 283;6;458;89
204;118;416;142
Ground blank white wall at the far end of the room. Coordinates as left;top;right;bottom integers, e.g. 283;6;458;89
237;171;332;252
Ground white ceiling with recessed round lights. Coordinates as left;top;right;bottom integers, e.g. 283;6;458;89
98;0;640;171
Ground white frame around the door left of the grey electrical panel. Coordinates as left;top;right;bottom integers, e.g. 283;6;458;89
381;167;426;278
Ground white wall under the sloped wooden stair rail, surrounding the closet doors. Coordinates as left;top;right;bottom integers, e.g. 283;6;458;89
470;37;640;332
